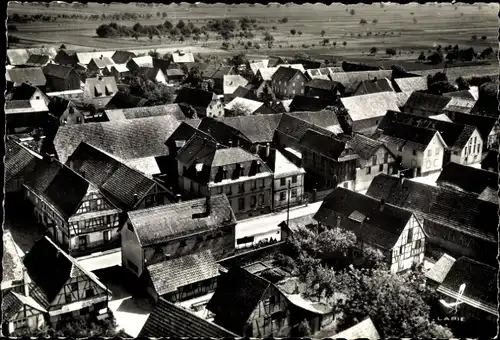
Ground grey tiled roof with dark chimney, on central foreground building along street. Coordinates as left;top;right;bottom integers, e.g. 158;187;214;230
128;194;236;247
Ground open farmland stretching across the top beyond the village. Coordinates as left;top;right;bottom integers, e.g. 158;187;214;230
8;3;498;69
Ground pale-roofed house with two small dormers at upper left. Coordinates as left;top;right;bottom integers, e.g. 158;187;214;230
83;76;118;109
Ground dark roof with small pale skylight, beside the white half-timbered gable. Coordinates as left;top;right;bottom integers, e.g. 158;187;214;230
314;187;412;249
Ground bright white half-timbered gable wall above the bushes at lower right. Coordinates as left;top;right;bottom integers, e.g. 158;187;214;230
390;216;425;273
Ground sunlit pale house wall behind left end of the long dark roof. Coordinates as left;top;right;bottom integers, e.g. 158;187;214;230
354;147;395;192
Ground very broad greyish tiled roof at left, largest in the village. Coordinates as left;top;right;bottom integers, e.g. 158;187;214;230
54;115;180;162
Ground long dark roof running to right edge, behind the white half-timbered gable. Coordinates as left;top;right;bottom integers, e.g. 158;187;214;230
366;174;498;242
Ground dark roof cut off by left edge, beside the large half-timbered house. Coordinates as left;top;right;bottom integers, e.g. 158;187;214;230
4;139;38;182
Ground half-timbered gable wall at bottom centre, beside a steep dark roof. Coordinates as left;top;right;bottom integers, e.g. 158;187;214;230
243;286;290;338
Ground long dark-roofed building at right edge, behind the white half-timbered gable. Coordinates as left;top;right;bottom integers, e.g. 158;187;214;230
367;174;498;265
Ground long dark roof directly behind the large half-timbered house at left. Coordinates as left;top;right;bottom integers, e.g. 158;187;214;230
66;142;162;209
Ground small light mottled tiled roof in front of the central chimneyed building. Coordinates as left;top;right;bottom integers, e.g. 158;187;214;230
147;250;222;296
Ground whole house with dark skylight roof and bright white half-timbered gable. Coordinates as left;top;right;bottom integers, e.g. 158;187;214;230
314;187;425;273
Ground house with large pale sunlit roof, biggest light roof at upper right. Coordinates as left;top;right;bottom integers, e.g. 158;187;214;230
337;92;399;136
